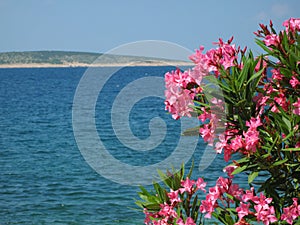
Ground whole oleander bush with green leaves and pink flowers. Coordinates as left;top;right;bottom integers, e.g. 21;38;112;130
137;18;300;225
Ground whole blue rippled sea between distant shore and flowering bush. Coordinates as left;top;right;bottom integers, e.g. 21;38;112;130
0;66;244;225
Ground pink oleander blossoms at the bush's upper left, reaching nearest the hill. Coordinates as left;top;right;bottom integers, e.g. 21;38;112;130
165;39;239;119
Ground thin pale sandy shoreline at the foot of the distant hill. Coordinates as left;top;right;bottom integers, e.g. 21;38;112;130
0;61;193;69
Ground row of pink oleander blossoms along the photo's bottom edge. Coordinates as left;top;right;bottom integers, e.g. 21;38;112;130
144;174;300;225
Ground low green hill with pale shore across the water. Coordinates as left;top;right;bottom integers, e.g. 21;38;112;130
0;51;192;67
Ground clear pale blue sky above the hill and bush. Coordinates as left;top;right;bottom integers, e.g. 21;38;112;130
0;0;300;53
